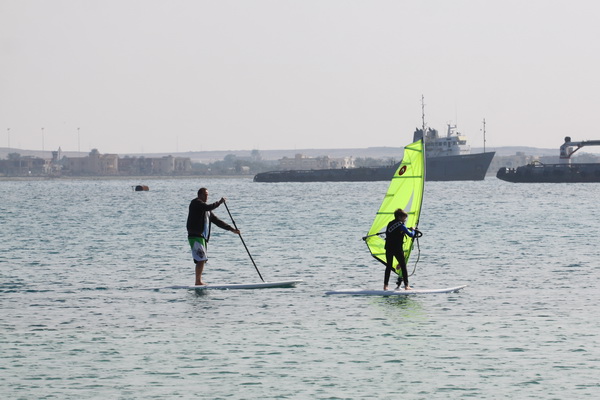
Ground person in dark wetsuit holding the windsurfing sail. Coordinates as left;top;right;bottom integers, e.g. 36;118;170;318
383;208;417;290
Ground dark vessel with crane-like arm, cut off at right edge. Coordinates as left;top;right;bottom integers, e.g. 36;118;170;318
496;136;600;183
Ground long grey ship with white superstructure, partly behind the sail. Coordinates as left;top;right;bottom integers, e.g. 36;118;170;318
254;125;495;182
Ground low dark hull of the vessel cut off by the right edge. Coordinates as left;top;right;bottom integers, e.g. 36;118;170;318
496;163;600;183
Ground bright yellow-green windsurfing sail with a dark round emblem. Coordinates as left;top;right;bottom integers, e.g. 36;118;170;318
364;139;425;275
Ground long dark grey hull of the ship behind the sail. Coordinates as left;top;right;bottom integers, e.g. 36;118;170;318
254;152;495;182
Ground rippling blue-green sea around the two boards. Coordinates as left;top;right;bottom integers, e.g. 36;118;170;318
0;176;600;399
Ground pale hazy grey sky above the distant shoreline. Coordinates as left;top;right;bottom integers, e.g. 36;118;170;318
0;0;600;153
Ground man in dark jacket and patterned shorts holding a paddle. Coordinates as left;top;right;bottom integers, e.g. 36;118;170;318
186;188;240;286
